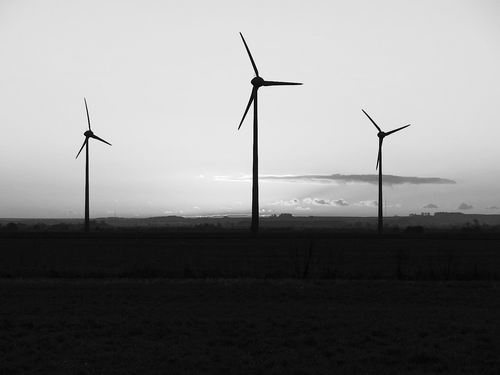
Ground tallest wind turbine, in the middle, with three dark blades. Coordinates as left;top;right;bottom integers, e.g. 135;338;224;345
238;33;302;233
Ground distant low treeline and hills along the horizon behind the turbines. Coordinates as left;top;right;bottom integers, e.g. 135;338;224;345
0;215;500;234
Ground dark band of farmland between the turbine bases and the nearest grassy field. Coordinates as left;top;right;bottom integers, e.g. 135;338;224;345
0;233;500;280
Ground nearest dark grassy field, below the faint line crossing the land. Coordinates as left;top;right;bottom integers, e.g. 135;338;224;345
0;279;500;375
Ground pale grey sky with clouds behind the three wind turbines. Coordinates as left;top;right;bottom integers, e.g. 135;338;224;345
0;0;500;218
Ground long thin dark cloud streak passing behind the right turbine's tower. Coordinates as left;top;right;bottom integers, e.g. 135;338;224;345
259;174;456;185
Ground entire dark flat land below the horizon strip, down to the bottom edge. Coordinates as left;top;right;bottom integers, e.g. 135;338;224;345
0;232;500;375
